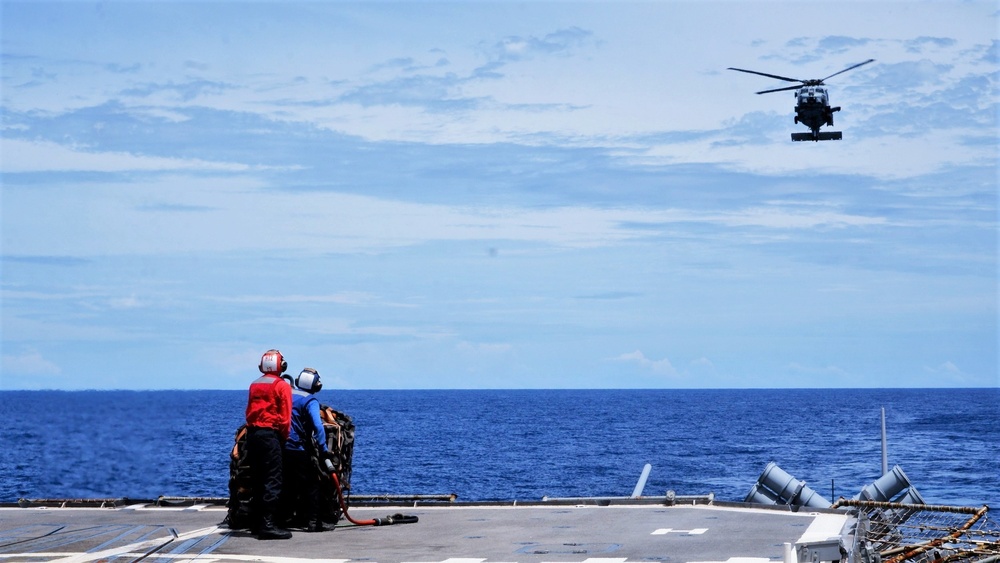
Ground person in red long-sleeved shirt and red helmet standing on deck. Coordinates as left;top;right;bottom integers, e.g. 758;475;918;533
246;350;292;540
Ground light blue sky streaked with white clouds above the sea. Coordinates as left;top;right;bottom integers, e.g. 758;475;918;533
0;0;1000;390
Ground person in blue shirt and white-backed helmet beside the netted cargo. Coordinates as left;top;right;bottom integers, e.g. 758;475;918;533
282;368;327;532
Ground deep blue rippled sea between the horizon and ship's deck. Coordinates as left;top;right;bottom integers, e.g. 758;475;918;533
0;388;1000;507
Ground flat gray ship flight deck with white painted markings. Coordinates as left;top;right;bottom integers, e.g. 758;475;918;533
0;505;844;563
